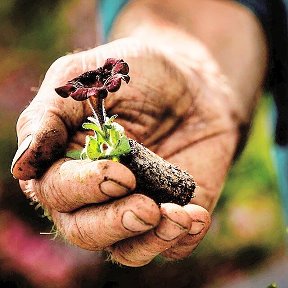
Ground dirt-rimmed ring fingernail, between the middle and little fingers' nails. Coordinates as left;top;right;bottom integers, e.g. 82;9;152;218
155;217;187;241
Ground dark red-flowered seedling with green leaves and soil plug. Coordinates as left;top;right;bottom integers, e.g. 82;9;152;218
55;58;196;206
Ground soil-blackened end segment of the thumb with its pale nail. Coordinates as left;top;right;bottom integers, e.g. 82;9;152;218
11;104;67;180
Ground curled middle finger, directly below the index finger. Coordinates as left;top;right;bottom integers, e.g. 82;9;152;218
52;194;160;250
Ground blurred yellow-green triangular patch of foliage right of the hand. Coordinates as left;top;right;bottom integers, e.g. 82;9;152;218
199;96;285;260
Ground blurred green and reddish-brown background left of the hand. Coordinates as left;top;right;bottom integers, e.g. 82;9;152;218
0;0;74;228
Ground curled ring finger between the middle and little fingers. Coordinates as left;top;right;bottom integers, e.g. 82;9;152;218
109;203;191;267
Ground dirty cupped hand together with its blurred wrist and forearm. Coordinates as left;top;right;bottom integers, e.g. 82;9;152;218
13;0;267;266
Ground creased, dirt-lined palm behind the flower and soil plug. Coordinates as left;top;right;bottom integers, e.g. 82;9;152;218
101;49;238;210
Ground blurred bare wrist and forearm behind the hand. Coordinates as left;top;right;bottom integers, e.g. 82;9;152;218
111;0;268;126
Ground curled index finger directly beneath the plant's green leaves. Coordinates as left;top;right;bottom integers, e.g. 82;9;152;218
24;158;136;212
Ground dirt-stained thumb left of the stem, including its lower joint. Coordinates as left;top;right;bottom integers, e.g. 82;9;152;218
11;84;83;180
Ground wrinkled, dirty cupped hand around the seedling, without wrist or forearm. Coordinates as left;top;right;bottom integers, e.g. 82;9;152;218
12;39;238;266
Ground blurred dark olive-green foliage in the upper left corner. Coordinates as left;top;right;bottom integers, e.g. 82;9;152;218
0;0;73;77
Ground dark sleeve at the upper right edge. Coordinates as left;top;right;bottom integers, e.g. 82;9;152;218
235;0;288;146
